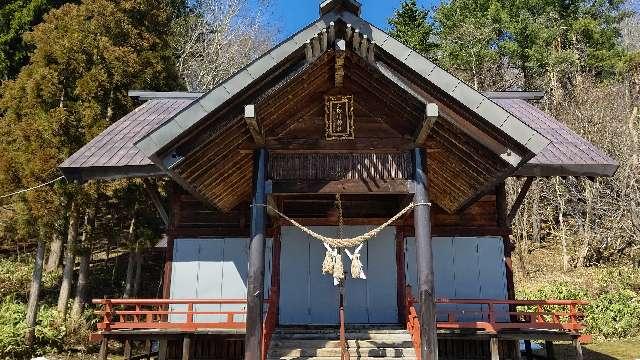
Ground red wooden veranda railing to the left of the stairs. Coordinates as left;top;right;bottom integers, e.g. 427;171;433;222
93;299;247;331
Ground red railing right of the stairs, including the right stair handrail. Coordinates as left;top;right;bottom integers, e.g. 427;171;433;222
405;286;588;360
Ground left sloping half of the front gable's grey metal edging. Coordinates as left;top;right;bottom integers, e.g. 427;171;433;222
135;12;344;158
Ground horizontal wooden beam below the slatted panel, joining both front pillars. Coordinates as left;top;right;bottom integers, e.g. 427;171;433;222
267;179;414;195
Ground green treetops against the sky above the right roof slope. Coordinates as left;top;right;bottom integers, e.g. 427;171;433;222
389;0;630;90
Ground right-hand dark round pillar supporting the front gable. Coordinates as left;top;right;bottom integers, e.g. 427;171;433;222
413;149;438;360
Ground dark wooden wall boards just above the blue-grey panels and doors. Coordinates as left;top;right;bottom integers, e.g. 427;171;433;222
172;184;502;238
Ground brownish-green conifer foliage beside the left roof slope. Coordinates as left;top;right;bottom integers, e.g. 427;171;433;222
0;0;180;246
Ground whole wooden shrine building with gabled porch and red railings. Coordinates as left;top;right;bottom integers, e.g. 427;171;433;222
60;0;617;360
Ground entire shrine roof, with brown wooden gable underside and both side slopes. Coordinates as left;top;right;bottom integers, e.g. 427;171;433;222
61;0;617;212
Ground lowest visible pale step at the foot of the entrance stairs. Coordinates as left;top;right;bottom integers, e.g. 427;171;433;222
269;347;416;358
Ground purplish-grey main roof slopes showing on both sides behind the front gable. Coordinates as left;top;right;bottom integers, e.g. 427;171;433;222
60;92;618;181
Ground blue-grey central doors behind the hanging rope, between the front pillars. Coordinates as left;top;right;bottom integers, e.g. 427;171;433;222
279;226;398;325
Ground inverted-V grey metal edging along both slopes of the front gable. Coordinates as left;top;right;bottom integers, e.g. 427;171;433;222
136;5;549;163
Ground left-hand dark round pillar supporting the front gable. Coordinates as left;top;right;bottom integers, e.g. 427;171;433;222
244;148;267;360
